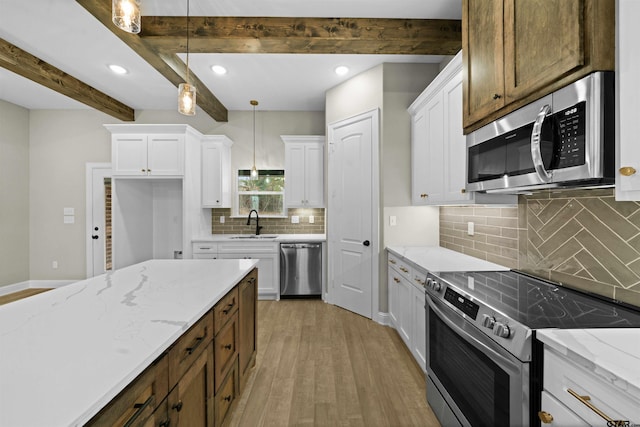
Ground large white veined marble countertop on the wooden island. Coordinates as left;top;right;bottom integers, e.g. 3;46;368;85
0;259;257;427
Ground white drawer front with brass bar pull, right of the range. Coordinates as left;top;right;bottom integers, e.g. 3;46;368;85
544;348;640;425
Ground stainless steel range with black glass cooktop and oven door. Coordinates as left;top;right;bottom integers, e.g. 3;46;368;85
426;271;640;427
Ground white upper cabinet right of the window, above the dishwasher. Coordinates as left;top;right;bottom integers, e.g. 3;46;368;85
280;135;324;208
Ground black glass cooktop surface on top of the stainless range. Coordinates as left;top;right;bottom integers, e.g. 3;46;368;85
434;271;640;329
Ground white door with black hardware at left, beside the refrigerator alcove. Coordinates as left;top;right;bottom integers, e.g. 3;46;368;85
86;163;111;277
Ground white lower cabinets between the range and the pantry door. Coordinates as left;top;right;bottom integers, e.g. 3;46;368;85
387;254;427;372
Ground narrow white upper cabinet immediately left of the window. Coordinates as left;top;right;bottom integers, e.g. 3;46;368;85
202;135;233;208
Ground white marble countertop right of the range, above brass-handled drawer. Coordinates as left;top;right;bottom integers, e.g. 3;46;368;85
536;328;640;400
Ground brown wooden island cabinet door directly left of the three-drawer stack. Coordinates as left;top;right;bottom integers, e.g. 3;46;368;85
168;342;214;427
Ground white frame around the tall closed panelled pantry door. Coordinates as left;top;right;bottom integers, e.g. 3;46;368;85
326;108;386;324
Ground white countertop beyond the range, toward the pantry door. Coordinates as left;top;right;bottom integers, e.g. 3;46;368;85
387;246;509;272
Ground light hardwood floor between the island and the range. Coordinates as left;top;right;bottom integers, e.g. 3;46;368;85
228;300;439;427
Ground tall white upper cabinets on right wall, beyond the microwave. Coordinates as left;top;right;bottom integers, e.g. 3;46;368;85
409;52;517;205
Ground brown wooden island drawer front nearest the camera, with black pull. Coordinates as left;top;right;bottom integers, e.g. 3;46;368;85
85;357;169;427
